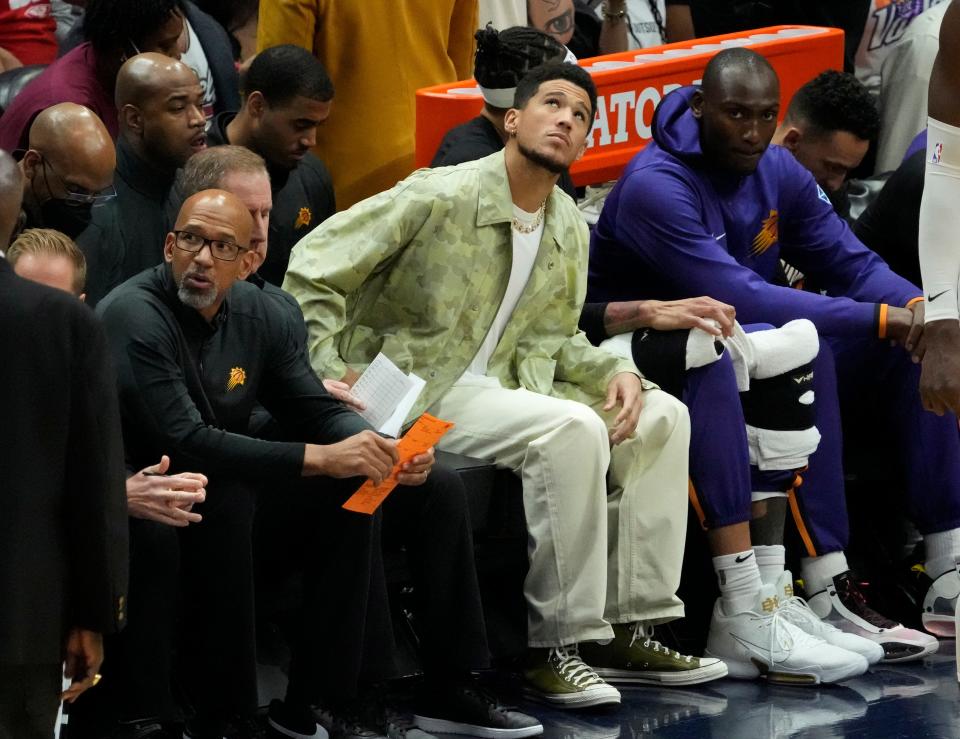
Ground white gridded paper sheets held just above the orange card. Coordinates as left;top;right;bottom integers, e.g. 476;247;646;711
350;354;427;436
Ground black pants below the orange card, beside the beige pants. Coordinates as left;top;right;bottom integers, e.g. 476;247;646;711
256;466;489;704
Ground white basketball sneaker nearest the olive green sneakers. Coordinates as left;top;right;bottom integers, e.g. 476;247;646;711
706;585;868;685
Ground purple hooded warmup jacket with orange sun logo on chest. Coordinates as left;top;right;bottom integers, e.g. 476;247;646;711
587;87;922;337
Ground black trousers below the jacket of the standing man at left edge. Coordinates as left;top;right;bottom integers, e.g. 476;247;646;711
0;664;63;739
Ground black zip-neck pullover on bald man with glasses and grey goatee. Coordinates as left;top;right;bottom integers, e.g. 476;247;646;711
97;264;370;479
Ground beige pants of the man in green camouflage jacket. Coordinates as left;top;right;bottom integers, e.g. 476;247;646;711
430;378;690;647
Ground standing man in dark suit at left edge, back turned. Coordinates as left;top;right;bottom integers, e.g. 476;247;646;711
0;152;127;739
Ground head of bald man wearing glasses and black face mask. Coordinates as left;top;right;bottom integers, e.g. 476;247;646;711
18;103;116;239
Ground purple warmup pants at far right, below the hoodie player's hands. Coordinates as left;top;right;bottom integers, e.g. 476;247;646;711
796;338;960;556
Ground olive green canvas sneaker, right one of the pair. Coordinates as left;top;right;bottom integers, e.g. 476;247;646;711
580;622;727;686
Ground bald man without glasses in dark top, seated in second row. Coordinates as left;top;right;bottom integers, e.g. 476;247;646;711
77;53;206;305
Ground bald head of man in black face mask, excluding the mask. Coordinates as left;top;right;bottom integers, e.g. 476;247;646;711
24;103;117;199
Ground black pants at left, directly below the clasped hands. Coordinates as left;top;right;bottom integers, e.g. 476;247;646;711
70;482;266;737
